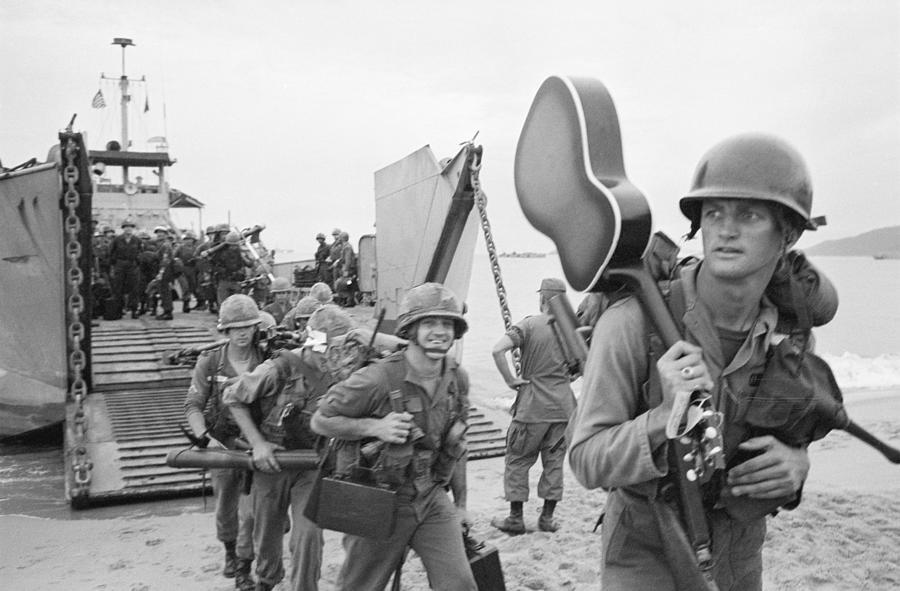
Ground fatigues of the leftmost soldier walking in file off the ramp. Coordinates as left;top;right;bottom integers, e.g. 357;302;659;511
184;344;260;560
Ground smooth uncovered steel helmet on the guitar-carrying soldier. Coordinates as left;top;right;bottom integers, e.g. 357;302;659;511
679;133;825;236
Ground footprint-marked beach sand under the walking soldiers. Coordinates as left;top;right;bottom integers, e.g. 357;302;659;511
0;390;900;591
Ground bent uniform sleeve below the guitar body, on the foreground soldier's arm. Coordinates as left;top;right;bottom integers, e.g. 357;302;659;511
567;298;667;489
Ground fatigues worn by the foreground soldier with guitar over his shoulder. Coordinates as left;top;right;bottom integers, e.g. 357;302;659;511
569;265;778;591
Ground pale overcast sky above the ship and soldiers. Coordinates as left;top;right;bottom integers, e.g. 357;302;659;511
0;0;900;260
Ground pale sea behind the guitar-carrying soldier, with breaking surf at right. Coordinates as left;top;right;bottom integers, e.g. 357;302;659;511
463;252;900;406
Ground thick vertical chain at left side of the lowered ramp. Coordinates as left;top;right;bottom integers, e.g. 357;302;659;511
63;137;93;498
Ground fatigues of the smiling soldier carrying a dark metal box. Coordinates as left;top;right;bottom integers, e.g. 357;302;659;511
319;352;476;591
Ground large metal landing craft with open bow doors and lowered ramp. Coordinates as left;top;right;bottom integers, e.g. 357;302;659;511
0;39;504;508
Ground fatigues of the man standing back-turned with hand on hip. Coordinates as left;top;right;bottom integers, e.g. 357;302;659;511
503;314;575;502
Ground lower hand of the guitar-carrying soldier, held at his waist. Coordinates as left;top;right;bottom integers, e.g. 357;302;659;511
726;435;809;499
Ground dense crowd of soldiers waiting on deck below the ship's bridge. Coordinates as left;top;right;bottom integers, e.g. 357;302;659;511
91;219;272;320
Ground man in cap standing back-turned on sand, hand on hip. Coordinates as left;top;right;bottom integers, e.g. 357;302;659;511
491;278;575;534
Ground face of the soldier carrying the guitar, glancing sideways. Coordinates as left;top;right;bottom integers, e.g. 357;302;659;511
700;199;786;279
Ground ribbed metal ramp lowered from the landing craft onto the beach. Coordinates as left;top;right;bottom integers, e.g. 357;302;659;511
66;306;505;505
